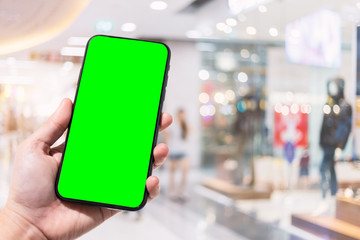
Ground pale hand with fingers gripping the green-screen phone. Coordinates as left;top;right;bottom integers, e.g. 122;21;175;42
0;99;172;240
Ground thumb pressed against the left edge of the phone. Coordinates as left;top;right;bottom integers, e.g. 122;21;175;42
32;98;72;147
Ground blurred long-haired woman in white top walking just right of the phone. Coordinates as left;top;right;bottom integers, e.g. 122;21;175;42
166;109;189;200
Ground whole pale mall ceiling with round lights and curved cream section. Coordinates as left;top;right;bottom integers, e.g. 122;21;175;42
0;0;360;54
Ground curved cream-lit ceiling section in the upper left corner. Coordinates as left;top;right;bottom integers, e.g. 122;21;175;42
0;0;90;54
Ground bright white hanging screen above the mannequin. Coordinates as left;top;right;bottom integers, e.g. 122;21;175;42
285;10;341;68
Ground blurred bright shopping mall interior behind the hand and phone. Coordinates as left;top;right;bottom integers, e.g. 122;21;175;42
0;0;360;240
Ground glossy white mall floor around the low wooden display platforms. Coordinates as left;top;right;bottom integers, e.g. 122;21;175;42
80;168;321;240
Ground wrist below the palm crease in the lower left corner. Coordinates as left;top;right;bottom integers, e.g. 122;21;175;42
0;207;47;240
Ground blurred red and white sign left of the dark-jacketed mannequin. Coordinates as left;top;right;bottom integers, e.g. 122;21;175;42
274;105;308;147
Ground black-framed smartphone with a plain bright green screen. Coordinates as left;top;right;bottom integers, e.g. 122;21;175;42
55;35;170;210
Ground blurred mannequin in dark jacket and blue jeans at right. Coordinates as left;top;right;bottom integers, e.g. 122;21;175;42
317;78;352;214
